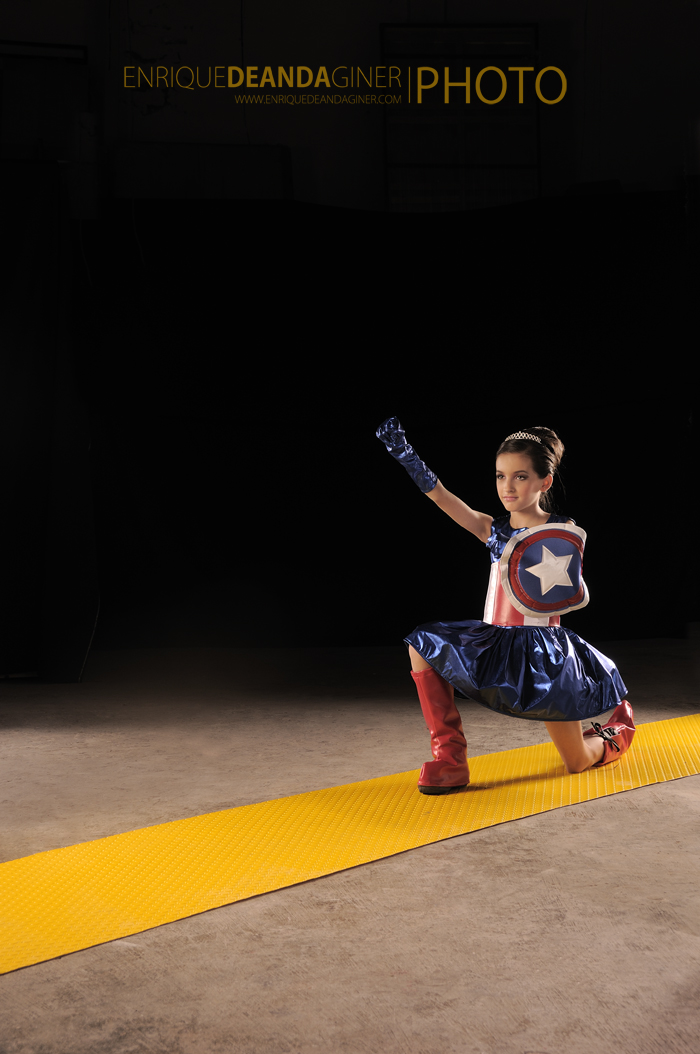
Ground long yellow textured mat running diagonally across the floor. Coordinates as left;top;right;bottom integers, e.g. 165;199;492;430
0;715;700;973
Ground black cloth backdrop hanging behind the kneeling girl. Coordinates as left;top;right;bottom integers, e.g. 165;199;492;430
3;165;694;680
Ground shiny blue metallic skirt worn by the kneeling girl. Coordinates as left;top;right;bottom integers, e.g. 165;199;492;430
404;619;627;721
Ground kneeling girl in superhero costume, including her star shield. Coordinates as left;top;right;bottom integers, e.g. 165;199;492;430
375;416;636;795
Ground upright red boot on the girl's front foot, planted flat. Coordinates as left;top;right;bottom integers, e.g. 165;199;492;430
411;667;469;794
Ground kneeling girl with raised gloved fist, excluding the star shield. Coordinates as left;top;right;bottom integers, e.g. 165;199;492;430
376;417;635;794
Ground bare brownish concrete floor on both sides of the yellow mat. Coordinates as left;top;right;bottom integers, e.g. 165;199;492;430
0;625;700;1054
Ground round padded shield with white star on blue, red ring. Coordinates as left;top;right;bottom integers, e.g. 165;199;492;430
500;524;588;618
